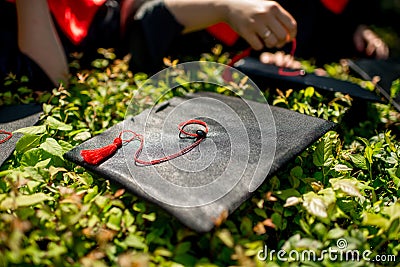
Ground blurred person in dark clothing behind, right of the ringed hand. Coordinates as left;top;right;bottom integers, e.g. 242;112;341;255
260;0;389;68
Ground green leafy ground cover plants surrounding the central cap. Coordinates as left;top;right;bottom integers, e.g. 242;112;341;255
0;47;400;267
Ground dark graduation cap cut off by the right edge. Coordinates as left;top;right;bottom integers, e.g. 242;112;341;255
348;59;400;111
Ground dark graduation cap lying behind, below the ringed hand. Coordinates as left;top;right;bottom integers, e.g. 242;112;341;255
235;57;382;102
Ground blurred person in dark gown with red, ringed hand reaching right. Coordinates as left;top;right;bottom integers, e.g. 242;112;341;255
0;0;297;90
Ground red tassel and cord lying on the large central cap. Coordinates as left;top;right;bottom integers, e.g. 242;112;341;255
81;119;208;166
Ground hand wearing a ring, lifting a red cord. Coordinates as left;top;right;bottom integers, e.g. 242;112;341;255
224;0;297;50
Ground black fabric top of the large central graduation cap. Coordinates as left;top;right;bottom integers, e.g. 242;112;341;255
64;92;335;232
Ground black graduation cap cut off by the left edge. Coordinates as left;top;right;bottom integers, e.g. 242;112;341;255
0;104;42;166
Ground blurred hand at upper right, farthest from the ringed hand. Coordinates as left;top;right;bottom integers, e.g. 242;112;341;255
353;25;389;59
